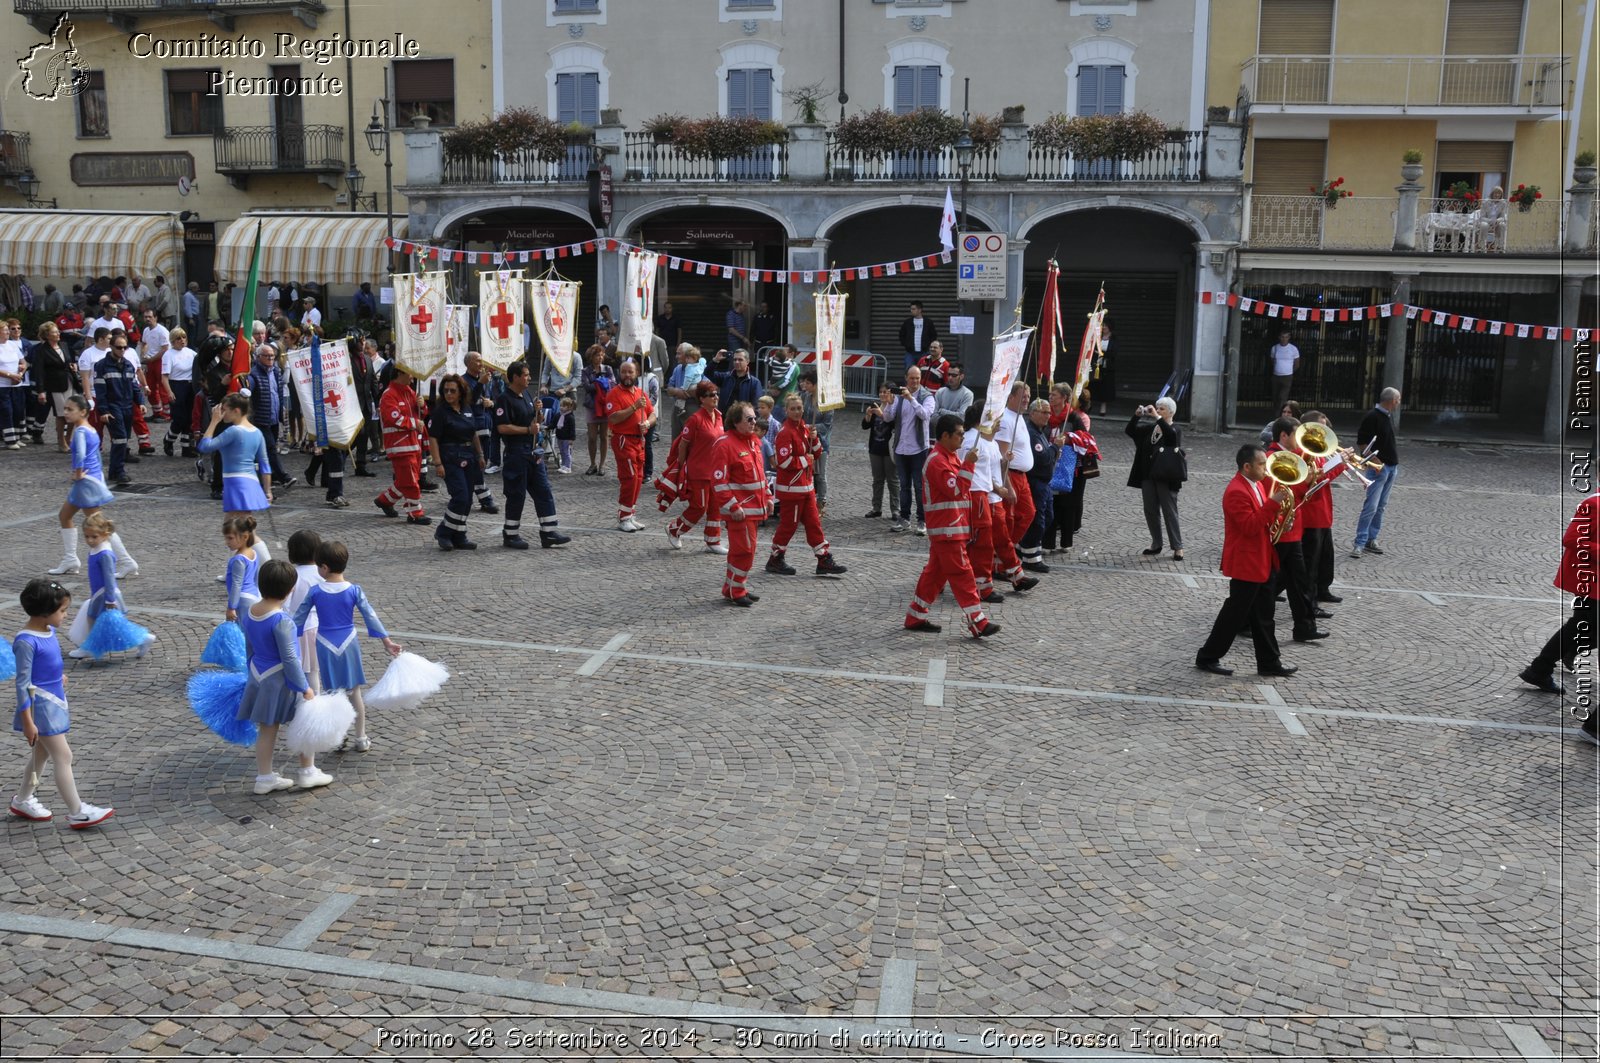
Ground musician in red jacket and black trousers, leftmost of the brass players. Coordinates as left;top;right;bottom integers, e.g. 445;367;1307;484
1195;443;1299;676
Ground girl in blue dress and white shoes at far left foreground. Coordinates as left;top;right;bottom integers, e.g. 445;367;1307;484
11;580;114;831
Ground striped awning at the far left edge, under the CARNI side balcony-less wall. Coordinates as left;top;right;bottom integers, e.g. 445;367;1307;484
0;210;184;279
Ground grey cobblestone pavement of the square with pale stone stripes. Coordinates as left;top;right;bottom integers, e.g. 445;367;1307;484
0;419;1600;1058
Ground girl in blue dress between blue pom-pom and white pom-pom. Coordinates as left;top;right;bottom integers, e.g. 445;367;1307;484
229;560;333;794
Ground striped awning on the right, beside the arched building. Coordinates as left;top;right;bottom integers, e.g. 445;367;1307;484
216;215;406;285
